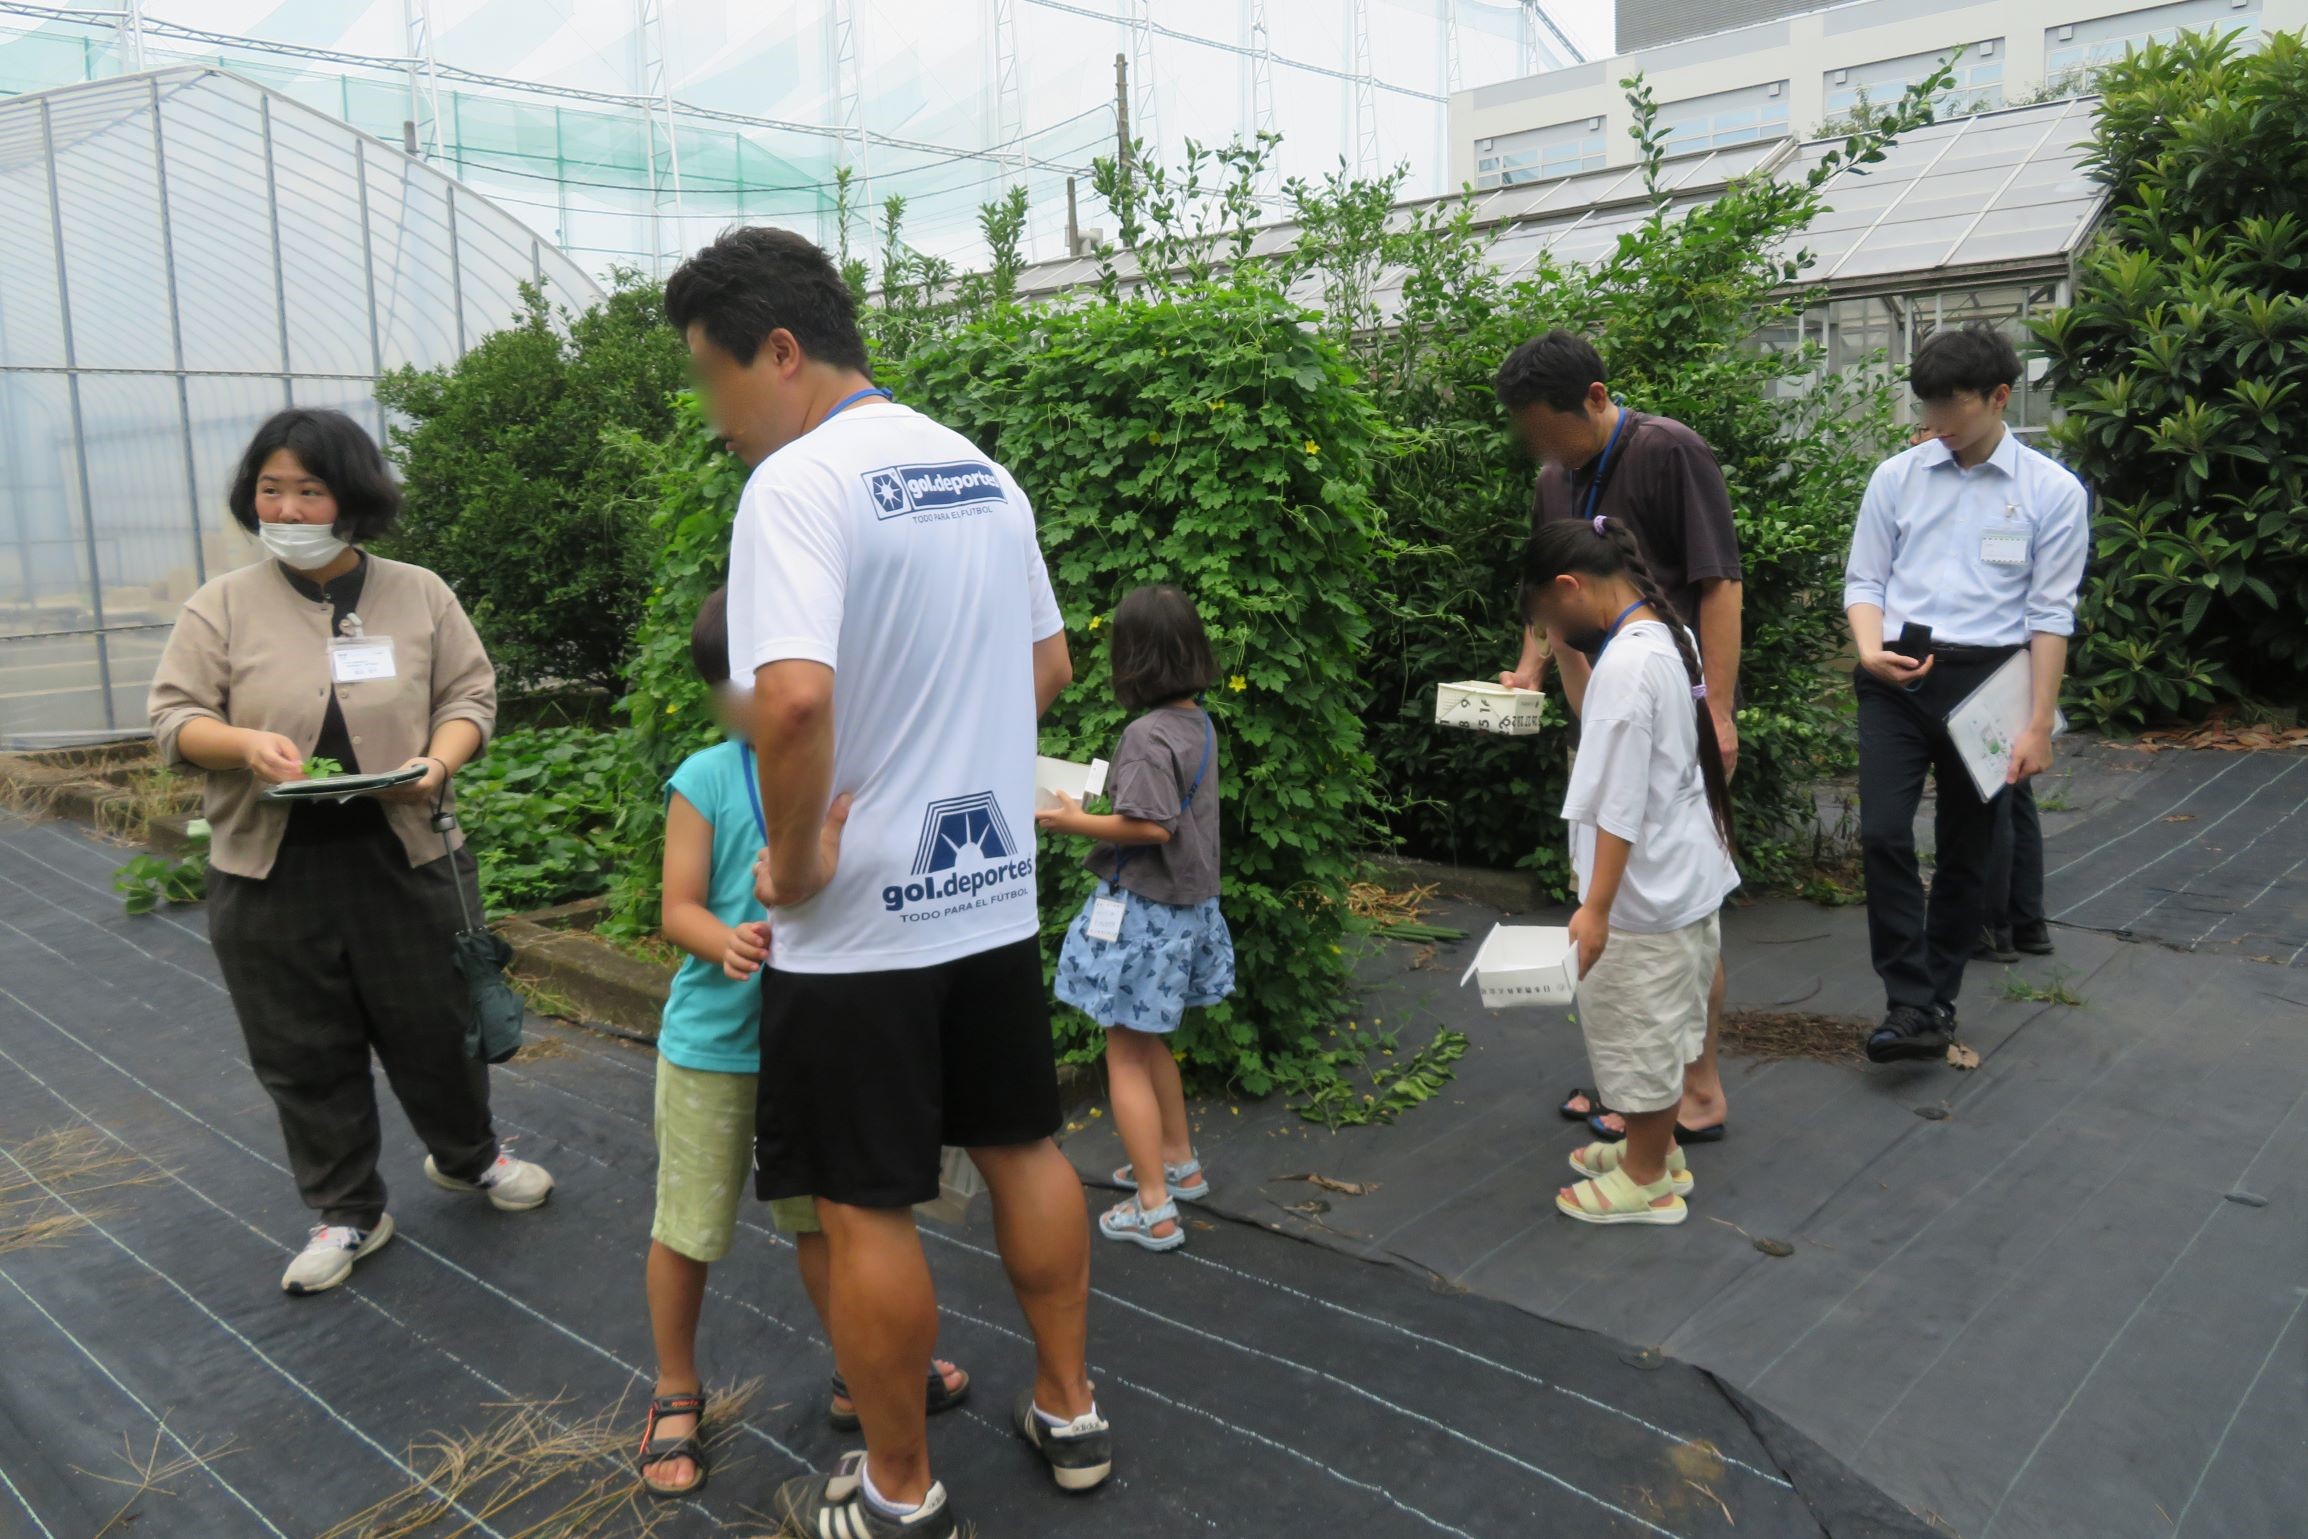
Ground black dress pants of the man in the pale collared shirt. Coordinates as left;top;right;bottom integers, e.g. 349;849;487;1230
1853;653;2008;1011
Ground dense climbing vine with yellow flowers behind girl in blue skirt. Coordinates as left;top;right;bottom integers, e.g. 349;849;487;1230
893;281;1380;1094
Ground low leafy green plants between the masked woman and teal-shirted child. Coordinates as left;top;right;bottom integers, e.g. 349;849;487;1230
457;727;625;918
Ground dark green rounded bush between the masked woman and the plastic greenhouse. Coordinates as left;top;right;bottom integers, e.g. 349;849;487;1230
376;279;688;690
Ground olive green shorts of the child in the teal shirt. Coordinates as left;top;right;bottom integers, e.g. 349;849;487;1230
649;1054;817;1262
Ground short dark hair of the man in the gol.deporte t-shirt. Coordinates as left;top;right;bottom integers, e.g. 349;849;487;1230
665;226;866;374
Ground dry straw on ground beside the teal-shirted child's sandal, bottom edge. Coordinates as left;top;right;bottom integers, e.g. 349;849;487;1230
319;1380;759;1539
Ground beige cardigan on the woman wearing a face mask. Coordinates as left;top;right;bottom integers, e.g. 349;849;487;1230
148;556;496;879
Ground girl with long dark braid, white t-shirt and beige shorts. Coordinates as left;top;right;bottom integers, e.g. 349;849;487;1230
1523;517;1738;1223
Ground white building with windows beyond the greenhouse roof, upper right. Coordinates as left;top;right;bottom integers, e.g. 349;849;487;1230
1449;0;2280;189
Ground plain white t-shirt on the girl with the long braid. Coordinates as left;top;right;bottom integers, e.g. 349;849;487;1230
1563;621;1738;934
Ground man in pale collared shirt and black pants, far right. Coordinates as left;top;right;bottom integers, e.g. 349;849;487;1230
1844;325;2091;1064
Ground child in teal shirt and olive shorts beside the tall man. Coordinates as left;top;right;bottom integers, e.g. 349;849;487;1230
639;588;969;1497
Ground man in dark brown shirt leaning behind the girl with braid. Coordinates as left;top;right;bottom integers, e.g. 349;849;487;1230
1493;330;1740;1142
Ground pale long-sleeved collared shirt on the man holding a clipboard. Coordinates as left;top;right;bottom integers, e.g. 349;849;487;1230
1844;429;2091;646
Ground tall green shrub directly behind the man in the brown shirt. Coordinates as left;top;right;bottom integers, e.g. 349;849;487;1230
1286;76;1936;891
